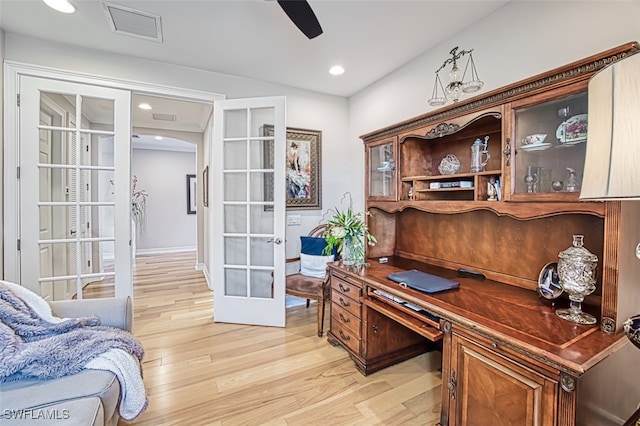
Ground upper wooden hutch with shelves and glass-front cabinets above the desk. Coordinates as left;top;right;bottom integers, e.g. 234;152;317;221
362;42;638;332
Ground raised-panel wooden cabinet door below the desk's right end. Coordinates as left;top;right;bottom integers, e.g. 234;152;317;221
442;333;557;426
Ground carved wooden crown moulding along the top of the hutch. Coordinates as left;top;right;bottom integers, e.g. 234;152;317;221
362;45;637;142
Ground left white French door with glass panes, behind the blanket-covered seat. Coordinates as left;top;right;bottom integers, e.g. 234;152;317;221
18;76;133;298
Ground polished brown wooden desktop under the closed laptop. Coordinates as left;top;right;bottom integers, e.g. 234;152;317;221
331;258;626;376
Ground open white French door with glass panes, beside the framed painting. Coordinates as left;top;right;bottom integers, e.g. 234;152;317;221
209;97;286;327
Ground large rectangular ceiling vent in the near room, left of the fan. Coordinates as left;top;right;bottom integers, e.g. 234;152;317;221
102;2;162;43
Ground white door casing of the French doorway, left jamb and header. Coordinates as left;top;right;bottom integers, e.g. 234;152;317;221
3;61;225;296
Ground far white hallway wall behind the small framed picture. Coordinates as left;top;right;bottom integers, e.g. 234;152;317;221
131;149;197;253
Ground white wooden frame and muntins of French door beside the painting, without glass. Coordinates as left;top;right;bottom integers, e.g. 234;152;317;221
209;96;286;327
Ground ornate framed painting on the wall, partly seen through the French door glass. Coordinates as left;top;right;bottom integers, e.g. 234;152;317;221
262;124;322;210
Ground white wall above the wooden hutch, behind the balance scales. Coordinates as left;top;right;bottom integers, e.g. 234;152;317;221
349;0;640;139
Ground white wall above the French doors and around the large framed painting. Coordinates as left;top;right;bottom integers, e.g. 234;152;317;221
5;33;350;262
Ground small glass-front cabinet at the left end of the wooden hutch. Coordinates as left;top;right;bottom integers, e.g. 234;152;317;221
366;136;398;201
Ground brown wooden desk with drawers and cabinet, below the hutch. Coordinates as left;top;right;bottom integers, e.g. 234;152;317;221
328;259;627;425
